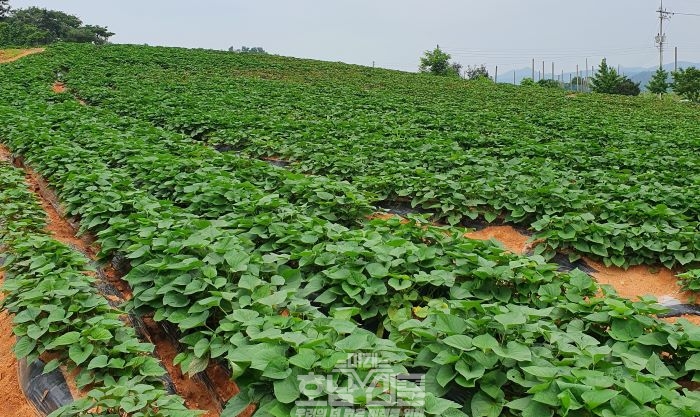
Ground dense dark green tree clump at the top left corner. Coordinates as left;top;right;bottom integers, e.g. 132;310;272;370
0;0;114;47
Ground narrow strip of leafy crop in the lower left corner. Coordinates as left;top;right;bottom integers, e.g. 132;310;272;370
0;163;197;417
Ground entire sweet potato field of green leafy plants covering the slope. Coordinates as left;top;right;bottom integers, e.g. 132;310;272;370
0;45;700;417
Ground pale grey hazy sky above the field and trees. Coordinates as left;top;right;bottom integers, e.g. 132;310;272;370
10;0;700;73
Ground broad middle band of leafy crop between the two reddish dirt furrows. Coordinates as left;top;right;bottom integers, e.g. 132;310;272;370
0;46;700;417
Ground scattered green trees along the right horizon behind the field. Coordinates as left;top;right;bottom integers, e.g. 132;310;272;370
419;45;700;103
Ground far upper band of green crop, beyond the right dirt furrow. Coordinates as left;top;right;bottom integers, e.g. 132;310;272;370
47;46;700;267
